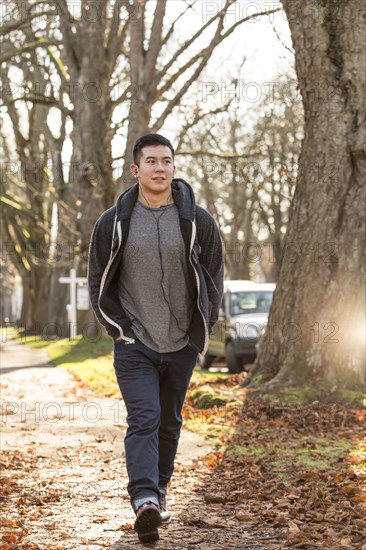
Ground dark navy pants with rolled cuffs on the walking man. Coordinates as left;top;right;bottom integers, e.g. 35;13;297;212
114;339;198;512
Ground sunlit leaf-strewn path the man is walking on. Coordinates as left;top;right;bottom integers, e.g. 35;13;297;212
0;341;281;550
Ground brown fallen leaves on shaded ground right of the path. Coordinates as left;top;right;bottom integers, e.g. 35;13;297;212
186;375;366;550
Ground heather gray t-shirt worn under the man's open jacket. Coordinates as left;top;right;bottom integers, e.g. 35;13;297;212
118;201;194;353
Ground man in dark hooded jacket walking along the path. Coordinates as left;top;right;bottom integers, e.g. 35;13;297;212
88;134;223;542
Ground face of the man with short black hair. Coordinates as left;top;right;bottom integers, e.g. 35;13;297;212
131;145;175;195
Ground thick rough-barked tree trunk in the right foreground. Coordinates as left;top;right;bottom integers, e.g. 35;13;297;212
249;0;366;388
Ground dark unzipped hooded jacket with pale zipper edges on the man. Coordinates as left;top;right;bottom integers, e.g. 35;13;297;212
88;179;224;353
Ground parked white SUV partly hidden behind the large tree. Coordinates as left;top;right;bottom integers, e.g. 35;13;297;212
201;281;276;373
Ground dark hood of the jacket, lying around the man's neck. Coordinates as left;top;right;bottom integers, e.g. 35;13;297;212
116;178;196;221
